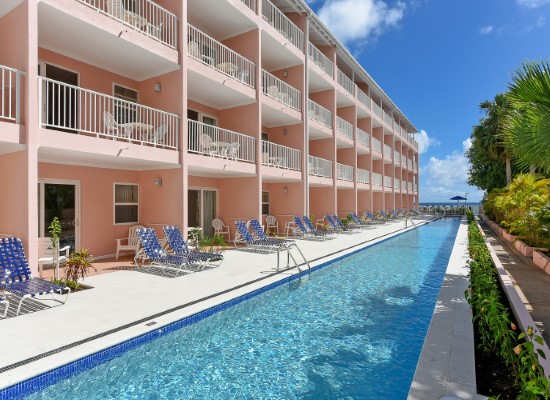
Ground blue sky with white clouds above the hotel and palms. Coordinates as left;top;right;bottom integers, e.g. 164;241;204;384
307;0;550;203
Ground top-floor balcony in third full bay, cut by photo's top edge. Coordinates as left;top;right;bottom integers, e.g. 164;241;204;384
260;0;305;71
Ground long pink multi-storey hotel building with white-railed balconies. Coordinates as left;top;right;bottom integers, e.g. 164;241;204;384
0;0;418;267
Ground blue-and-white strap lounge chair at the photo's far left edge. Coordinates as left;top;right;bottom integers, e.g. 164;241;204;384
0;238;71;316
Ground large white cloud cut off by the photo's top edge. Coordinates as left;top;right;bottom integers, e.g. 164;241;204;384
317;0;406;44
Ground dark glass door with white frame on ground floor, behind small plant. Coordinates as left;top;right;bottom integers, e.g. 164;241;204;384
38;180;80;252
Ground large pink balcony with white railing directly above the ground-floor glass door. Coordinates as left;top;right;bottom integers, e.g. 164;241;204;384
38;77;179;169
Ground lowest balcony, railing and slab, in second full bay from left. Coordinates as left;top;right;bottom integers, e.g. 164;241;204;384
187;120;256;177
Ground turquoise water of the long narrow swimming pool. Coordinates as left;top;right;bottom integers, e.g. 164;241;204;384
30;219;459;400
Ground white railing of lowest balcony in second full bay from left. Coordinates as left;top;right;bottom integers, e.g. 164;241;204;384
187;120;256;163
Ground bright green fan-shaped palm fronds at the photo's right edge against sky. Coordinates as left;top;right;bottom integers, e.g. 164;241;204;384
505;61;550;175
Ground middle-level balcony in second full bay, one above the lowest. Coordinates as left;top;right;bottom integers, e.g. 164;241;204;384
187;25;256;109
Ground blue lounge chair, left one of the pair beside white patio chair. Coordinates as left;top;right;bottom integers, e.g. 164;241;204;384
134;228;192;274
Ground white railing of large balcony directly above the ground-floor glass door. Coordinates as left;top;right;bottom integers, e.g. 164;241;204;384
38;77;178;149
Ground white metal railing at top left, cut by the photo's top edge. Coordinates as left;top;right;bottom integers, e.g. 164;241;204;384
76;0;178;49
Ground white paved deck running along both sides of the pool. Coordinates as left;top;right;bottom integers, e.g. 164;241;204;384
0;218;484;399
